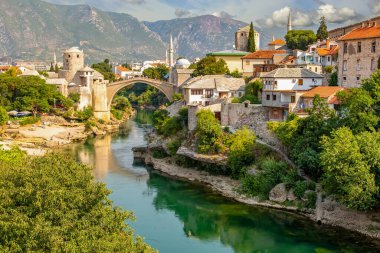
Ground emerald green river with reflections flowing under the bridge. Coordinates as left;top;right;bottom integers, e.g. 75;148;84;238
63;112;380;253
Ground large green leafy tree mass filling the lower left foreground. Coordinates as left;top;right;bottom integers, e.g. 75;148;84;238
0;149;154;253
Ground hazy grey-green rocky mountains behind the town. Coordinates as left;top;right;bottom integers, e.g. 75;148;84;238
0;0;270;63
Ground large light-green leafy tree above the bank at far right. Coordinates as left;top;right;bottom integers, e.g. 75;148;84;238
321;127;378;210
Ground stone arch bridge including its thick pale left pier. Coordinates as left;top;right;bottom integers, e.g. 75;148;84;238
93;77;175;121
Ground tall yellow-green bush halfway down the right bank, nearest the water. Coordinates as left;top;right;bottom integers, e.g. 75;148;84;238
228;127;256;178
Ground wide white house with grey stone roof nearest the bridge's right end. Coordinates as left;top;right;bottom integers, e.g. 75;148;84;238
183;75;245;106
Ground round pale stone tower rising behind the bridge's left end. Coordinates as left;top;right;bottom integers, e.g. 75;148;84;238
62;47;84;82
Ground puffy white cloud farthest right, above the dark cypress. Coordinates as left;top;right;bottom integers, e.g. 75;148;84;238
317;4;357;23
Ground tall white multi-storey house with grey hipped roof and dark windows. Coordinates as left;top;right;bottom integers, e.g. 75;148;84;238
262;68;323;120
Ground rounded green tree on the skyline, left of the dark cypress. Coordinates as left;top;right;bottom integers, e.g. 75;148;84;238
285;30;317;50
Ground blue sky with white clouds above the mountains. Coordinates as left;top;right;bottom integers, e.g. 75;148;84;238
44;0;380;29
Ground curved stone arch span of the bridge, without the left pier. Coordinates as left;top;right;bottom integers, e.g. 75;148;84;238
107;77;174;110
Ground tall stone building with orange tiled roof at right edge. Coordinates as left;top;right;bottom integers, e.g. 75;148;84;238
338;21;380;87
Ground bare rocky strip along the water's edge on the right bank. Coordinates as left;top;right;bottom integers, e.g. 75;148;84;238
134;148;380;239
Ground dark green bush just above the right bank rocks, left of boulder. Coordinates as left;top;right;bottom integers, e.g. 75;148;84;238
241;159;288;199
